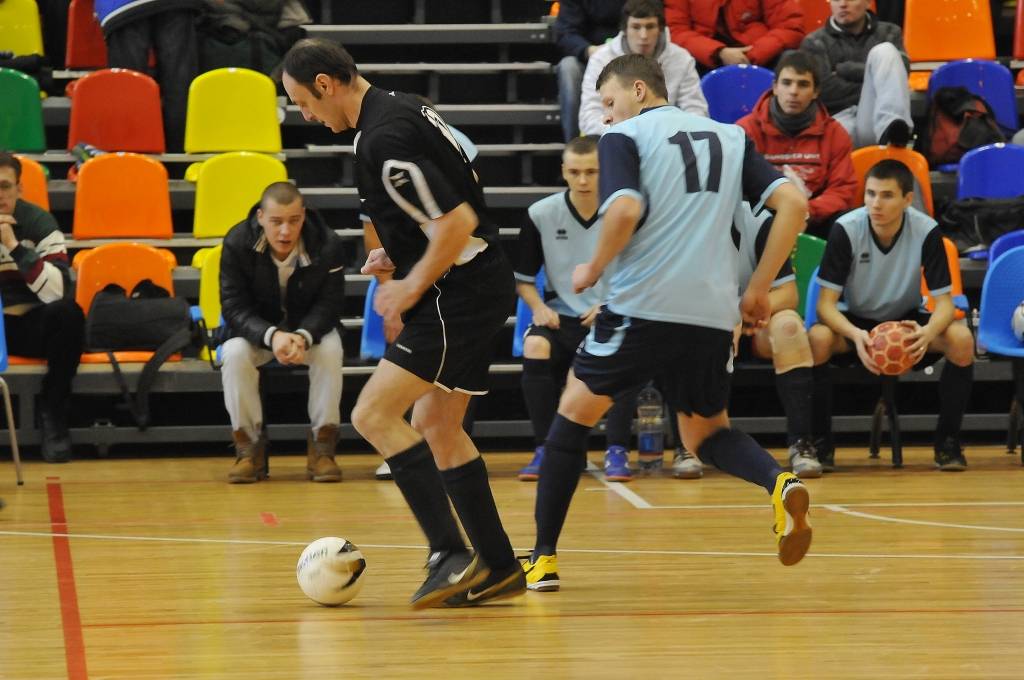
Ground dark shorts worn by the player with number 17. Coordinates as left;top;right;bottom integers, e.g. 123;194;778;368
572;307;732;418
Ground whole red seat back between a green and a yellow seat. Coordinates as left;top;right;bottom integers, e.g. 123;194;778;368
68;69;164;154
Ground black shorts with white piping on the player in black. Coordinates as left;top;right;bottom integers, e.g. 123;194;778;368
384;246;515;394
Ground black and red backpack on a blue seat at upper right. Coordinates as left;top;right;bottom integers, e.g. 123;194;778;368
918;87;1007;168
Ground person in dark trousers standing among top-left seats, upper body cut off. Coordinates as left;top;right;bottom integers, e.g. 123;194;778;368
95;0;199;152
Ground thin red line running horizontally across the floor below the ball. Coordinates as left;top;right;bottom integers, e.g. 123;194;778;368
85;605;1024;628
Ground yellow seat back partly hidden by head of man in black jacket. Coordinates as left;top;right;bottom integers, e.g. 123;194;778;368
193;152;288;239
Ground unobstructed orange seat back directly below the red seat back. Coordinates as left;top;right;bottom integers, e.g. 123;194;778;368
72;154;174;240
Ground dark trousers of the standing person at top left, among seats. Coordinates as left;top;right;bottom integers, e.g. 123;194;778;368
104;10;199;152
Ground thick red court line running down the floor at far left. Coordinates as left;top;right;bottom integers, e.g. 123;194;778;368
46;477;89;680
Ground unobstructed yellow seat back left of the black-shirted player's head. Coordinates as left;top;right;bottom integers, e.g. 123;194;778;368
185;69;281;154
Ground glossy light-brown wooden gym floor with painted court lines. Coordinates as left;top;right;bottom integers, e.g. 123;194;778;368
0;447;1024;680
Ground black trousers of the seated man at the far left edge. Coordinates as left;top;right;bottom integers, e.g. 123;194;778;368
3;299;85;416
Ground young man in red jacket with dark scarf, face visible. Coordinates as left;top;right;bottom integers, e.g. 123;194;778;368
736;50;857;239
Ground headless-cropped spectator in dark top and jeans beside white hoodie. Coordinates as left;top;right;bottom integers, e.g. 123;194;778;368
554;0;624;141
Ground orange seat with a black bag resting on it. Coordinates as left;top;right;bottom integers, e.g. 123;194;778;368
75;243;181;364
